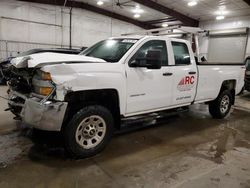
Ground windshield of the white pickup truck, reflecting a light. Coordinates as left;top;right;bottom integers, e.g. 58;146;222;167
81;39;138;63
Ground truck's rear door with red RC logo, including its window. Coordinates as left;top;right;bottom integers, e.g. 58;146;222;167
171;39;198;106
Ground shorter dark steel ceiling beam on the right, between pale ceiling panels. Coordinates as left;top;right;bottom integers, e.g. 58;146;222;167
133;0;199;27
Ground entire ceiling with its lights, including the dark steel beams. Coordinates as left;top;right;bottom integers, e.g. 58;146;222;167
19;0;250;29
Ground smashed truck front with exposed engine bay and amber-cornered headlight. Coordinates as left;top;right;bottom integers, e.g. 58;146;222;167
2;64;54;119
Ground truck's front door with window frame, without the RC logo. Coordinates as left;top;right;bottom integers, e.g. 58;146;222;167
125;39;173;116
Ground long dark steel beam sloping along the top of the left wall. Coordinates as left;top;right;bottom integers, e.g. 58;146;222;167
18;0;155;29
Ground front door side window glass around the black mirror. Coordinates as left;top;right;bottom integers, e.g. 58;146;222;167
130;40;168;66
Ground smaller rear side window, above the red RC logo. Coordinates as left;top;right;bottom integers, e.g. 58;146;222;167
172;42;191;65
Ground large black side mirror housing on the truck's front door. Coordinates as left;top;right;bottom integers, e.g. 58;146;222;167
146;50;162;69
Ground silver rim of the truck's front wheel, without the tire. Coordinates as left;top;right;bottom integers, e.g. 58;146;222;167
75;115;107;149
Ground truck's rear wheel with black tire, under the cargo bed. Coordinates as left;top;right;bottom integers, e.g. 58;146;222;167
209;90;233;119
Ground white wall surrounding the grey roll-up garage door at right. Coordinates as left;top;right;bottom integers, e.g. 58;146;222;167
200;16;250;57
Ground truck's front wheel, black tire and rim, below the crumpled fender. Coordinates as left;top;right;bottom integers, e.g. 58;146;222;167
63;105;114;158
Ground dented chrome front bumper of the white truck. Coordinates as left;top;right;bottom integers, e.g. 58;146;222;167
11;91;68;131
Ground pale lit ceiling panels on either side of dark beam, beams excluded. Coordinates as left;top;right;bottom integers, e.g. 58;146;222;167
75;0;250;23
